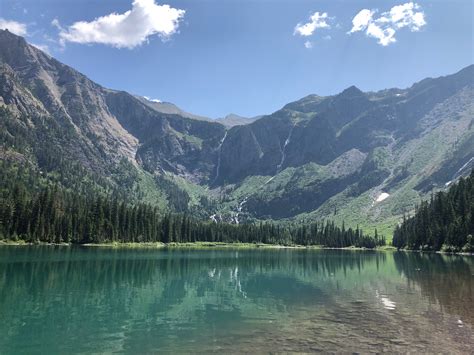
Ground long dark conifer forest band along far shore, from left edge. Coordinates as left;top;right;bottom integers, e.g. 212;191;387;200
0;160;385;248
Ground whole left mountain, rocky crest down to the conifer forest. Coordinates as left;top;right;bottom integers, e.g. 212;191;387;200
0;30;225;213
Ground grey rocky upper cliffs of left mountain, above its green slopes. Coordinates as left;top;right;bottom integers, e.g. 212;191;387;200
0;31;225;182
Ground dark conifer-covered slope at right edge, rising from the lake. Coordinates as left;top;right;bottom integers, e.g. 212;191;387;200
393;170;474;252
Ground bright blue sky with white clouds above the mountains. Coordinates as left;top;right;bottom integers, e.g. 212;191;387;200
0;0;474;117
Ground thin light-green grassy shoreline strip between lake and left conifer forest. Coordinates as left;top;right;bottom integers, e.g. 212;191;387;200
0;240;396;251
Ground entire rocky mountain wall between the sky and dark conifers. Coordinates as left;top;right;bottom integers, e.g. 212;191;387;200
0;31;474;236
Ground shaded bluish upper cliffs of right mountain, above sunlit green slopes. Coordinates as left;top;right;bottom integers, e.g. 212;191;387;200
216;66;474;186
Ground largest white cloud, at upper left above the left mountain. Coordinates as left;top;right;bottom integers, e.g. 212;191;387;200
57;0;185;49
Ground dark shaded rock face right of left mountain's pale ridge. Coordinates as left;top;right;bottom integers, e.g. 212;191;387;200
106;92;225;183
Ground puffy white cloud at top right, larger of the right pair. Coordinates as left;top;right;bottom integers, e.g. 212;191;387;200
348;2;426;46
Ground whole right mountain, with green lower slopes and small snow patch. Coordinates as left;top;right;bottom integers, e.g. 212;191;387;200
215;65;474;234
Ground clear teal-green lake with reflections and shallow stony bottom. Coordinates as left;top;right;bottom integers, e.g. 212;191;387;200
0;246;474;354
